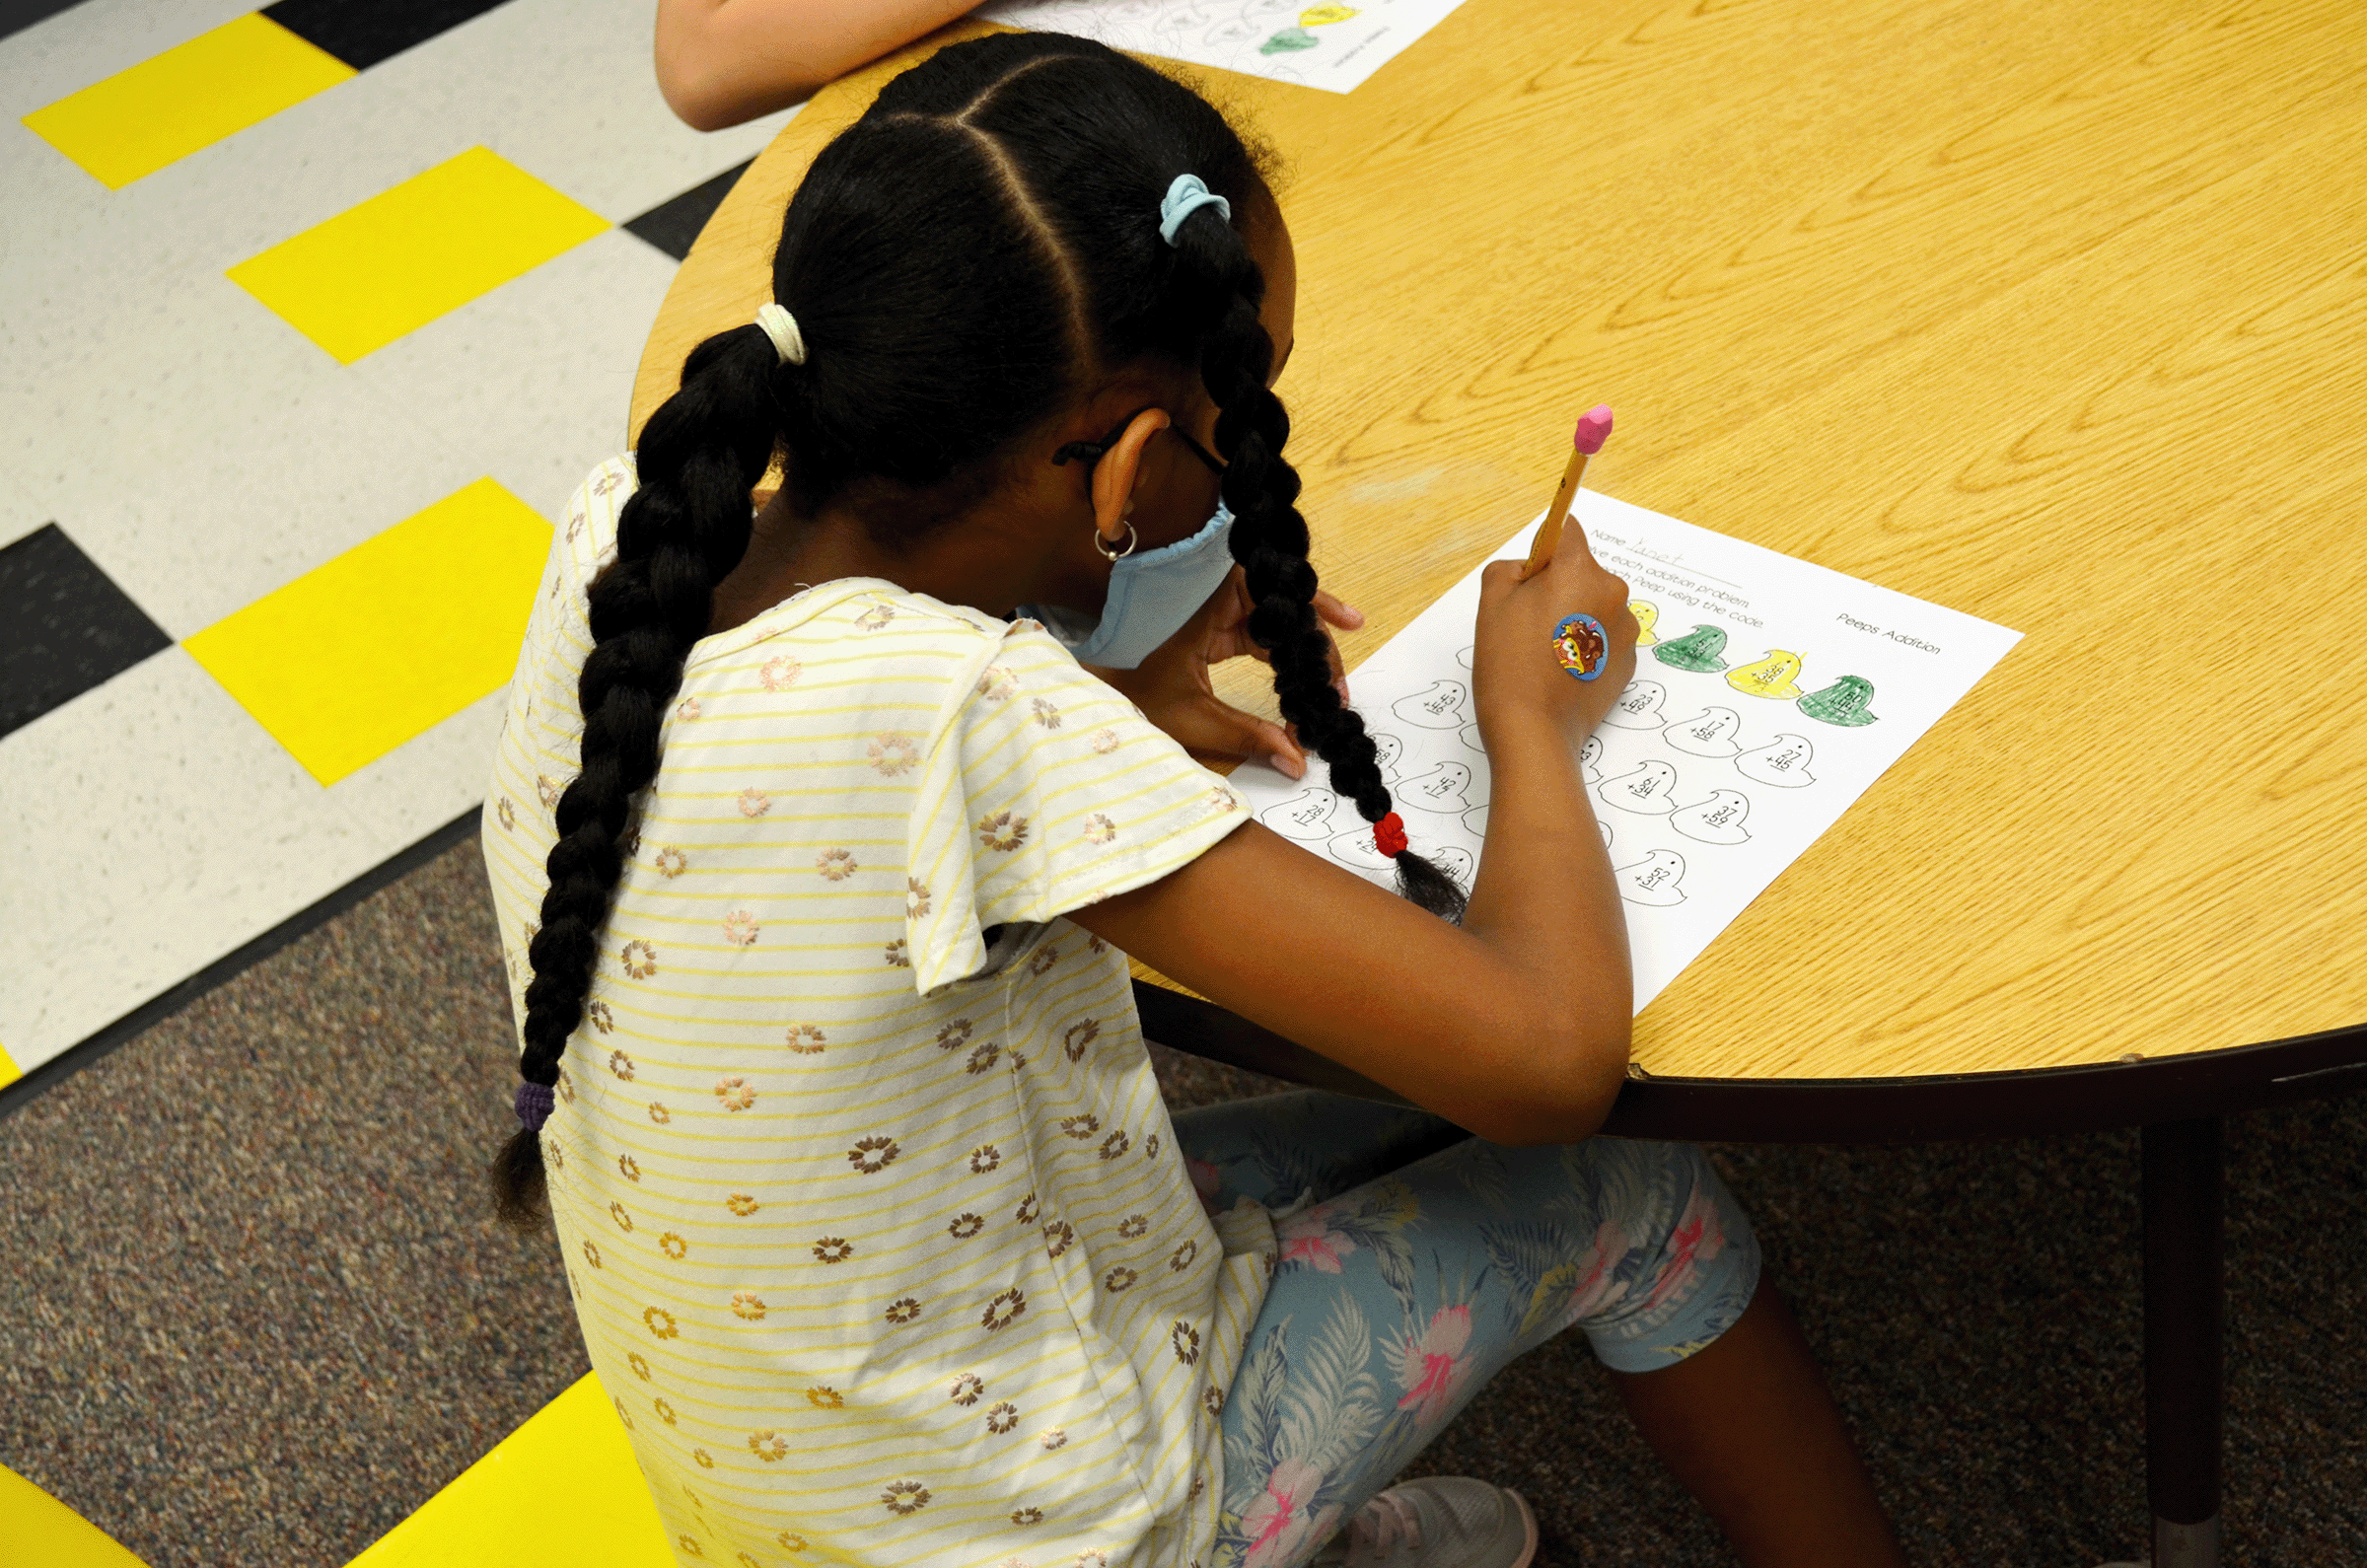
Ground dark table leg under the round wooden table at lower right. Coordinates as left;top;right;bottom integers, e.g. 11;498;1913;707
2142;1115;2227;1568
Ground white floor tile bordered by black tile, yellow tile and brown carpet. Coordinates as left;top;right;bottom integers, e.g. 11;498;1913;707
0;649;389;1068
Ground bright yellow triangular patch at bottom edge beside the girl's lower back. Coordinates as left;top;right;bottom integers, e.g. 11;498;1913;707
348;1374;675;1568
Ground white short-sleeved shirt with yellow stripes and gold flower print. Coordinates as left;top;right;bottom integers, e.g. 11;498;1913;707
485;460;1273;1568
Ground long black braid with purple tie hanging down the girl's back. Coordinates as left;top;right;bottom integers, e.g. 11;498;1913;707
492;326;786;1225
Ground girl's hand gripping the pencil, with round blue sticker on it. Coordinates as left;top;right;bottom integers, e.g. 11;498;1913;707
1472;519;1640;742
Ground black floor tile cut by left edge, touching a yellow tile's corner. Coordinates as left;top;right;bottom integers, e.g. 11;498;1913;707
0;524;173;735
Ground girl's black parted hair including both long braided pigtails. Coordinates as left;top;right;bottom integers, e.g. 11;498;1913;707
495;34;1463;1222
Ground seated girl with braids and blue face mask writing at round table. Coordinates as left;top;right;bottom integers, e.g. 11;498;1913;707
485;34;1899;1568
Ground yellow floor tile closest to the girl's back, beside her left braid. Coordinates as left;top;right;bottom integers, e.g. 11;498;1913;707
182;478;551;784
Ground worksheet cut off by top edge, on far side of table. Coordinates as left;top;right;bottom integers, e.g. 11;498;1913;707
977;0;1463;93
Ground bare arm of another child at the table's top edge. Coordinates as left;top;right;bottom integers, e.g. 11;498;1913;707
658;0;977;130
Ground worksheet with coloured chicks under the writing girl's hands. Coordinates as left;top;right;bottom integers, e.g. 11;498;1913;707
1231;490;2022;1028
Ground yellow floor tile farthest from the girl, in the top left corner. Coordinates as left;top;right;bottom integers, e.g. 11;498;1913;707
24;14;353;189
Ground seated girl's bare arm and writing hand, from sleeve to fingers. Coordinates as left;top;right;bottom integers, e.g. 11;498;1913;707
1070;540;1635;1144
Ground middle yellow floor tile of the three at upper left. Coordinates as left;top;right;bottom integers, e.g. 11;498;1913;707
230;147;609;365
